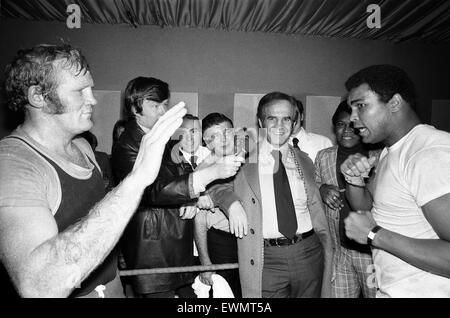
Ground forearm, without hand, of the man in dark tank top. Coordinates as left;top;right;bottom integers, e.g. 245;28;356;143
22;175;145;297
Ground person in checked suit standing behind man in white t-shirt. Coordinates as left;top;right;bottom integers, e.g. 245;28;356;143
315;99;380;298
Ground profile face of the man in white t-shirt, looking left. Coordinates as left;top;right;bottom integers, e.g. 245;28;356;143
347;84;391;143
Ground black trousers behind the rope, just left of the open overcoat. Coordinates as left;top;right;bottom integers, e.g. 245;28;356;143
208;228;242;298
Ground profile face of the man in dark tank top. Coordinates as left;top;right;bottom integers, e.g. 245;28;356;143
46;65;97;135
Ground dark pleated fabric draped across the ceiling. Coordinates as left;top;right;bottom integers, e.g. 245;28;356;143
0;0;450;43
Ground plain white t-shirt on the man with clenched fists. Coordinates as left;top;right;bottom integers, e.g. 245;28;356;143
372;125;450;297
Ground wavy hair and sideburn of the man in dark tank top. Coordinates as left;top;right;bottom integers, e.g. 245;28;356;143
5;44;89;113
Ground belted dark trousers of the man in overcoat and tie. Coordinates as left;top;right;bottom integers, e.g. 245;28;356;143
262;234;324;298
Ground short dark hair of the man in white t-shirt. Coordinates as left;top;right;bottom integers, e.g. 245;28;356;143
345;64;416;108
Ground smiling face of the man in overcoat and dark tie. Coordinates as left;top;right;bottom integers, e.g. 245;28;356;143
259;100;295;147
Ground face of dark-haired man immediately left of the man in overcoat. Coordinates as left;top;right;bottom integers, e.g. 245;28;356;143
203;121;234;157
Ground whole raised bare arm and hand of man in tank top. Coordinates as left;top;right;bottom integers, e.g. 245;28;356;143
0;103;186;297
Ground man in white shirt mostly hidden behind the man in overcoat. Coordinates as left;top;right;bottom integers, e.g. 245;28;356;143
289;99;333;162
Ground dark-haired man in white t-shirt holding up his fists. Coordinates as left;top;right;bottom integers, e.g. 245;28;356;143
341;65;450;297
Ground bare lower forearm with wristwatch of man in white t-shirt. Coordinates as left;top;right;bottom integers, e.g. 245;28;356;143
372;229;450;278
